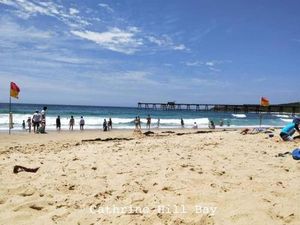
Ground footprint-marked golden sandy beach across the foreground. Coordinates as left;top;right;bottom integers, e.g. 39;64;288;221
0;130;300;225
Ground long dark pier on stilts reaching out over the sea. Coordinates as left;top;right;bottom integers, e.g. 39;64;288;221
138;102;300;115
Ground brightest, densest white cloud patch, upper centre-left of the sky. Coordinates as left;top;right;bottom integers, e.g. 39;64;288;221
71;27;143;54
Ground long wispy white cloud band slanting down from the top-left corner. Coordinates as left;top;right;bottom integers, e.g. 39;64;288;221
0;0;189;54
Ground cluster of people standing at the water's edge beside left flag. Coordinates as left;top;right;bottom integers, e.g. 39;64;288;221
22;106;47;133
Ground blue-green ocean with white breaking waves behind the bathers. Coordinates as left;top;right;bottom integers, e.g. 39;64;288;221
0;103;299;131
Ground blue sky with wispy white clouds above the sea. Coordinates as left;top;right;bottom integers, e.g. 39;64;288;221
0;0;300;106
